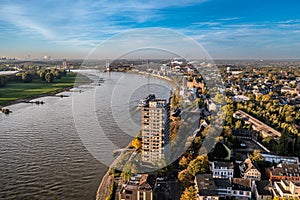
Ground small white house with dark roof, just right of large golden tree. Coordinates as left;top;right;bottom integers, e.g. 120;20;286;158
210;161;234;178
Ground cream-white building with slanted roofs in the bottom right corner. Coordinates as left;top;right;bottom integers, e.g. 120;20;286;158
272;180;300;199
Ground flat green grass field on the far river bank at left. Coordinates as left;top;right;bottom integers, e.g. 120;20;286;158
0;72;87;106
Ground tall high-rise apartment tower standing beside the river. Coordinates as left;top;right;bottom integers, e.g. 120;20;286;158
141;98;170;162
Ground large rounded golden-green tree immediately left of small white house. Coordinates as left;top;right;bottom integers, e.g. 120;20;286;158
187;155;209;176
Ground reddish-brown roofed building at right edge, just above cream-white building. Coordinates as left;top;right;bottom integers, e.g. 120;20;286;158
266;163;300;182
